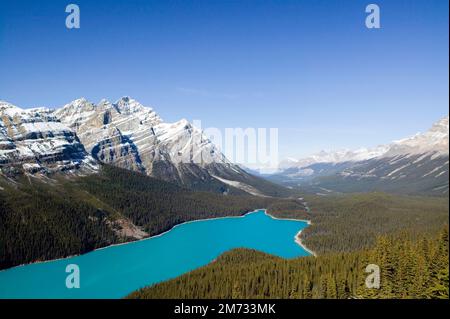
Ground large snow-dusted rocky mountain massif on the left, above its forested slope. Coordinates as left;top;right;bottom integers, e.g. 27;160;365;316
0;97;286;196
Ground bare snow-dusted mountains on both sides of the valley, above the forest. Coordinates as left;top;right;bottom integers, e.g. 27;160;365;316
0;97;449;196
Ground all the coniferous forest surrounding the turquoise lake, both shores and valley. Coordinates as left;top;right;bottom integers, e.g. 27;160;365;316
0;166;448;298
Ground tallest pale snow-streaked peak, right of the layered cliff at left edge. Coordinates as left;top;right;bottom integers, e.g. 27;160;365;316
54;97;236;182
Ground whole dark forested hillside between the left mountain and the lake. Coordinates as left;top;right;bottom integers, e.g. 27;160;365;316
0;166;302;269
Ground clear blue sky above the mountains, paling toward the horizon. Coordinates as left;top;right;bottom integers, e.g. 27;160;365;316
0;0;449;157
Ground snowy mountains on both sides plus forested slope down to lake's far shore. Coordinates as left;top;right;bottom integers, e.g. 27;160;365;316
0;97;449;268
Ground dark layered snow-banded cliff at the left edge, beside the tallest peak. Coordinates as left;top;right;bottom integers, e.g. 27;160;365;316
0;102;97;173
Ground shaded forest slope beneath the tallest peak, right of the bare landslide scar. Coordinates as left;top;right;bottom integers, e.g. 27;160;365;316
79;166;274;235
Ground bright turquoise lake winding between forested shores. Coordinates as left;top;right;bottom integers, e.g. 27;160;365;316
0;210;309;298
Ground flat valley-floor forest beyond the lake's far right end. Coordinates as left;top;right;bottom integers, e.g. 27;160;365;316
269;193;449;254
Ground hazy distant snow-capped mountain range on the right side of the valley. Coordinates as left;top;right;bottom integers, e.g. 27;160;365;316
268;116;449;195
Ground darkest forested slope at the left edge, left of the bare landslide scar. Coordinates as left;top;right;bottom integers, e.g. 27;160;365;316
0;183;118;269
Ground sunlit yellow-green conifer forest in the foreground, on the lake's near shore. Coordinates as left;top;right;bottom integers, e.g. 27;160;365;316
128;227;449;299
